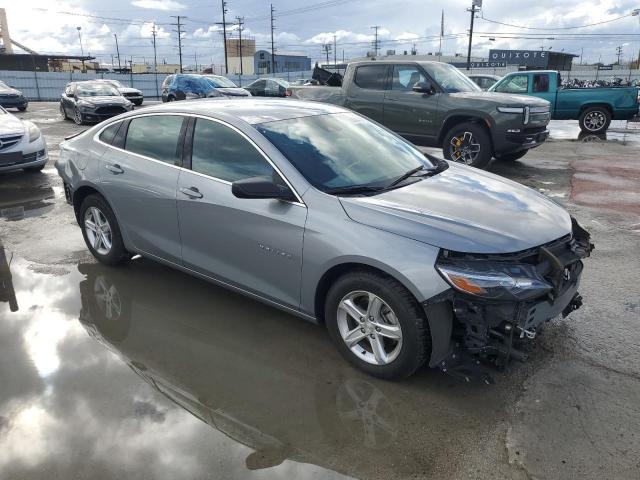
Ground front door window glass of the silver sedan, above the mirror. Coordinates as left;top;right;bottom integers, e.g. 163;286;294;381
191;118;273;182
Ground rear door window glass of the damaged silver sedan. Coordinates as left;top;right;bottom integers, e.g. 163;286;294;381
124;115;182;165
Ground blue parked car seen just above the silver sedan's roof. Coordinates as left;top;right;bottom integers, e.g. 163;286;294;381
162;73;251;102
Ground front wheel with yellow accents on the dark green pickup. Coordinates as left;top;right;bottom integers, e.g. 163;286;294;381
442;123;493;168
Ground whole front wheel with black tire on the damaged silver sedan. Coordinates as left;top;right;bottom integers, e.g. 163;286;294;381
325;270;431;379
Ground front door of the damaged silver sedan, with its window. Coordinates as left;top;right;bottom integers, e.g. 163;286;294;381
178;118;307;308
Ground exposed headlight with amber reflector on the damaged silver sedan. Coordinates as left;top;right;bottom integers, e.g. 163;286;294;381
436;260;553;301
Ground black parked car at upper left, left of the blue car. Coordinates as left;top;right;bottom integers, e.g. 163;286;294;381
60;81;133;125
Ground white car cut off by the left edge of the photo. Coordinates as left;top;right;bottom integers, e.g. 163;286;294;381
0;107;49;172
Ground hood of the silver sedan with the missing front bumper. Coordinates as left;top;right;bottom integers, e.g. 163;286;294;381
340;164;571;253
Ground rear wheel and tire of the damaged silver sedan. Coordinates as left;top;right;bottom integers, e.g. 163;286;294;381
80;194;131;266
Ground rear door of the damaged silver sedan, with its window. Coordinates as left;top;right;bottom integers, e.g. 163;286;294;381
100;114;186;264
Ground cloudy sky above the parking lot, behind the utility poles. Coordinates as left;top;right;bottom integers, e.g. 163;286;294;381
5;0;640;65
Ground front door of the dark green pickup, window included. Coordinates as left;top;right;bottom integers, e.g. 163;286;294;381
384;65;440;141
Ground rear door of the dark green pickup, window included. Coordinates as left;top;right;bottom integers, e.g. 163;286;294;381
345;64;389;123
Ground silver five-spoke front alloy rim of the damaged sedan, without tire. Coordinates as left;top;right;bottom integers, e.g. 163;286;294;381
337;291;402;365
